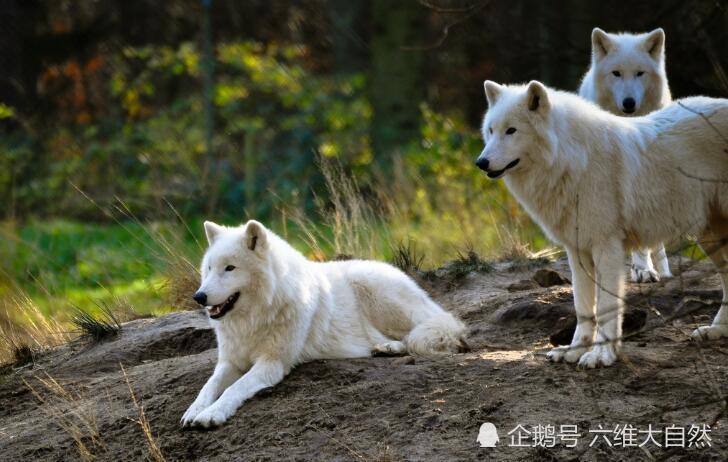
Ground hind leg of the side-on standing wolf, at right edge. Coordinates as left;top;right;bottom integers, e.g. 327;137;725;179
692;226;728;340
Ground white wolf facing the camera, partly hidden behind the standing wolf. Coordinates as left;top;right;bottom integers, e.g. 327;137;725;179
579;27;672;282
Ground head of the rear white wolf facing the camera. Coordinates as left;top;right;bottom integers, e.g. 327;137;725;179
592;27;670;116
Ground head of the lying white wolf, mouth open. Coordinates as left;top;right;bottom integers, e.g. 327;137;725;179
193;220;273;319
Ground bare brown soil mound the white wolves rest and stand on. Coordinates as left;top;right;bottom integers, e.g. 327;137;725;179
0;260;728;462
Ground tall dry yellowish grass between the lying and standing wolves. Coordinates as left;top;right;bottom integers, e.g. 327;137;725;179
283;153;538;272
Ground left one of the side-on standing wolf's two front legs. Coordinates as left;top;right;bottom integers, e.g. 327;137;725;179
546;249;595;363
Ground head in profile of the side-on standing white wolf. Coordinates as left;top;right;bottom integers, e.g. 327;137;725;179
475;80;556;178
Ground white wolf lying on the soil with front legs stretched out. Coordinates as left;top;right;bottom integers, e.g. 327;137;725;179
182;221;465;427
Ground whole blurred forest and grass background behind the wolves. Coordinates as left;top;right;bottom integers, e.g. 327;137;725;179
0;0;728;359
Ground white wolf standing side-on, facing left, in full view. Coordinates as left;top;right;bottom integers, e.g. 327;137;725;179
476;81;728;368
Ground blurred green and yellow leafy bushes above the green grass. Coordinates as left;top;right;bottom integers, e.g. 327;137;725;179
0;42;373;219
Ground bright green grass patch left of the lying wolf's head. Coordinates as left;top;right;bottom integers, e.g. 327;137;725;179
0;220;202;317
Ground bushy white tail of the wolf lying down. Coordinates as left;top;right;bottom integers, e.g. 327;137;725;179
404;311;469;355
